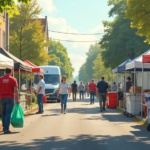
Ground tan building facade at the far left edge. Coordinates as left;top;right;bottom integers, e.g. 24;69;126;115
0;11;6;49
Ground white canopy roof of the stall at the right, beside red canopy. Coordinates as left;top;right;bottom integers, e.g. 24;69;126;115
126;50;150;71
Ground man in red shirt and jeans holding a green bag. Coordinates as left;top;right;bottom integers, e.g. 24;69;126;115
0;68;19;133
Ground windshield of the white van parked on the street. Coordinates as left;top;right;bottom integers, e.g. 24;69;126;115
44;75;60;84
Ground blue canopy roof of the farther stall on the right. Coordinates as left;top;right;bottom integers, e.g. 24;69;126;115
112;59;131;74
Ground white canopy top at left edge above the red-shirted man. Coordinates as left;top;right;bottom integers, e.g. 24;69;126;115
0;54;14;70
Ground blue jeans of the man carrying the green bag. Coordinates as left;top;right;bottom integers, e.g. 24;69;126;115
0;98;14;131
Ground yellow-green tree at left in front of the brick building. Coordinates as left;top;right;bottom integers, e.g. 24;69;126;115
10;0;52;65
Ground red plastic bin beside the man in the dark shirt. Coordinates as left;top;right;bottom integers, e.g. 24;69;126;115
108;92;118;108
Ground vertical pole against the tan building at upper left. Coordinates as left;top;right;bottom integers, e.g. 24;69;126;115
6;13;9;52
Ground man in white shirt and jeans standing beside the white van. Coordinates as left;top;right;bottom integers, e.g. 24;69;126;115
36;74;45;114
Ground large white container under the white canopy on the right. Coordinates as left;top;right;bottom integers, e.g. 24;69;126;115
126;93;141;115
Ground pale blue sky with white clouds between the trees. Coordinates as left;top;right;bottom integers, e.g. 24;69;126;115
38;0;112;77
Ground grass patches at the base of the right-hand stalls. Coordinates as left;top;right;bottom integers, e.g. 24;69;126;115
115;107;149;127
